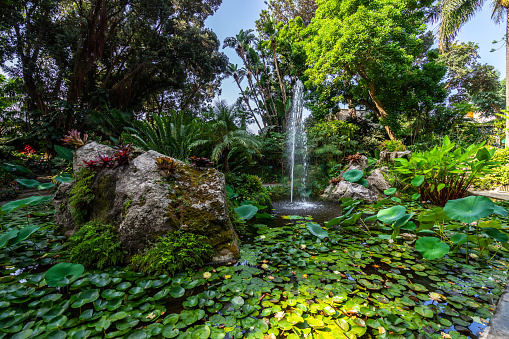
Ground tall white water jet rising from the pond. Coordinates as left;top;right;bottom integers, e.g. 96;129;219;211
286;80;307;202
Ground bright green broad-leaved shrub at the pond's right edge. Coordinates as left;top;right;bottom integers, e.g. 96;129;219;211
395;136;497;206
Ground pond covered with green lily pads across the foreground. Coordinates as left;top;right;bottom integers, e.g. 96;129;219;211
0;201;507;339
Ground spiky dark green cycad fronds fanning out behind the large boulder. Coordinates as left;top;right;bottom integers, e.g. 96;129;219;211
126;111;201;160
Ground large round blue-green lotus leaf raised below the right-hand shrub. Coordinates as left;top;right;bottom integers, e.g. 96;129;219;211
444;196;495;223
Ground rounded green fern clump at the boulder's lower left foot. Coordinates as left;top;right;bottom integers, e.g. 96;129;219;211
69;221;125;268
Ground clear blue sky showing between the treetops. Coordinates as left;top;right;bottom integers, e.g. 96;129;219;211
205;0;505;104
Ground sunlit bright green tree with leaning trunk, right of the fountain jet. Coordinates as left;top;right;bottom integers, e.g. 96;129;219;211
306;0;430;139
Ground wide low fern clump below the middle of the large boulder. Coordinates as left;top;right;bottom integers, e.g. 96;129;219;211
131;231;214;275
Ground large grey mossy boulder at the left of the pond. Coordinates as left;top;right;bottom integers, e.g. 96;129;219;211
54;143;239;262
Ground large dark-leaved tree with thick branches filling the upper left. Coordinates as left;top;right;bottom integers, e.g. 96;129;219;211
0;0;227;128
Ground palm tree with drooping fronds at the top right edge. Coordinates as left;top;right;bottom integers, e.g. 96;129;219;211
438;0;509;148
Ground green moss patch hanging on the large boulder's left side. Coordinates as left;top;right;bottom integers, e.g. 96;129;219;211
69;168;96;226
